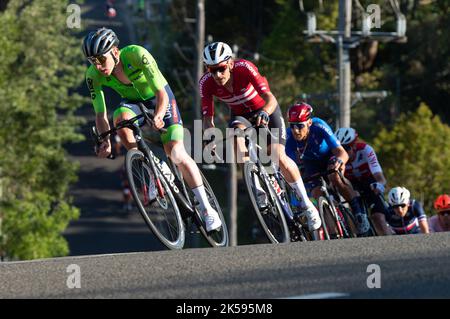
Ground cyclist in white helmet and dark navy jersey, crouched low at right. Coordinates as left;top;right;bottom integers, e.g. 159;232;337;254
383;187;430;235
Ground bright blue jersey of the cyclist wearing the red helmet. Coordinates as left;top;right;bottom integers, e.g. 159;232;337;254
286;117;341;165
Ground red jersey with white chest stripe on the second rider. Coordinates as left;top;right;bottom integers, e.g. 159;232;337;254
199;59;270;116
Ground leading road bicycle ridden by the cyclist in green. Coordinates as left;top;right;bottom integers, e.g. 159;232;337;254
92;103;229;249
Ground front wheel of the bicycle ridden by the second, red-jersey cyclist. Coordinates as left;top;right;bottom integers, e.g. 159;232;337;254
244;162;290;244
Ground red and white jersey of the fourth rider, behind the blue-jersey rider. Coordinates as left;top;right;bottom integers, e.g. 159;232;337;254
345;142;383;181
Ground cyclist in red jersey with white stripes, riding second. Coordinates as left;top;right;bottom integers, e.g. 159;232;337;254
199;42;321;230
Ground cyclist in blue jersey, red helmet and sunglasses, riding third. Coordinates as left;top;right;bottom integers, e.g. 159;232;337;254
286;102;370;236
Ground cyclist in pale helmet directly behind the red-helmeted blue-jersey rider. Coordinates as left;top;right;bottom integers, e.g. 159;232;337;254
335;127;386;234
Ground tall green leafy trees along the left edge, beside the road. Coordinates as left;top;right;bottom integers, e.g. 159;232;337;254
0;0;85;259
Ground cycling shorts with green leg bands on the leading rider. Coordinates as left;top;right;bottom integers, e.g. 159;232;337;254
113;85;184;144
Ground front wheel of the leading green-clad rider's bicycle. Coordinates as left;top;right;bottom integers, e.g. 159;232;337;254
125;149;185;249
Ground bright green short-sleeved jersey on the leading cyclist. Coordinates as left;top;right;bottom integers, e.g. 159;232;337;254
86;45;167;113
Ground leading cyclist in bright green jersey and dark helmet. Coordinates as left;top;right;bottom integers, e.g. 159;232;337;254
83;28;222;231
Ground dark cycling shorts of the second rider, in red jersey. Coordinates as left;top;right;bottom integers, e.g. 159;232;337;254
228;105;286;145
